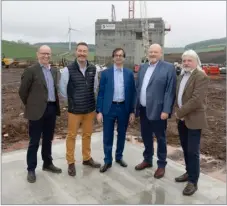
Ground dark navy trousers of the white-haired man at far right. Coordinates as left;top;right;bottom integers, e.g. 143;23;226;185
178;121;201;184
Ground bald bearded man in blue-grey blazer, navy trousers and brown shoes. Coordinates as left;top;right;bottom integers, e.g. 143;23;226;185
135;44;176;178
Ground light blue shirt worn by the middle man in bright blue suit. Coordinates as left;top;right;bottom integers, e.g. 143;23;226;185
113;65;125;102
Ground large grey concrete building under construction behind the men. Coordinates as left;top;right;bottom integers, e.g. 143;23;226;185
95;18;166;66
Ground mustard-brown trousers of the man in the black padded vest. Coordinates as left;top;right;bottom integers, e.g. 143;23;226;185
66;112;95;164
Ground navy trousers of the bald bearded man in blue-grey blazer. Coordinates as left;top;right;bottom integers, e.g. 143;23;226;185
140;106;167;168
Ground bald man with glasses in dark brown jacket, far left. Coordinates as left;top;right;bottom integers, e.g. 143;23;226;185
19;45;62;183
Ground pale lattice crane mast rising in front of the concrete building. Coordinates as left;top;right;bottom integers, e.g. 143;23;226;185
140;1;149;61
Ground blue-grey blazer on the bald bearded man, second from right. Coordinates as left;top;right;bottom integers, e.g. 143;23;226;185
136;61;177;120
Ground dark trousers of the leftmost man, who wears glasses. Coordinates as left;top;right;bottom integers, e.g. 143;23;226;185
27;103;56;171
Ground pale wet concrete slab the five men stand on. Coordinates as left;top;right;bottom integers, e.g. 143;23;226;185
2;133;226;204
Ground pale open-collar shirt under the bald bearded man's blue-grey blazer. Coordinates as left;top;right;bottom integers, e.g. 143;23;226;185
140;62;158;107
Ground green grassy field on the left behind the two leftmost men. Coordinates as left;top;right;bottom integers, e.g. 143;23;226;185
2;40;94;61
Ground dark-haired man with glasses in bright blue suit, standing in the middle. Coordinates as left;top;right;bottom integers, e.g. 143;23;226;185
97;48;136;172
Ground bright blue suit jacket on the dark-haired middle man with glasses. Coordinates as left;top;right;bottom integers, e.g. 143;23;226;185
96;66;136;115
